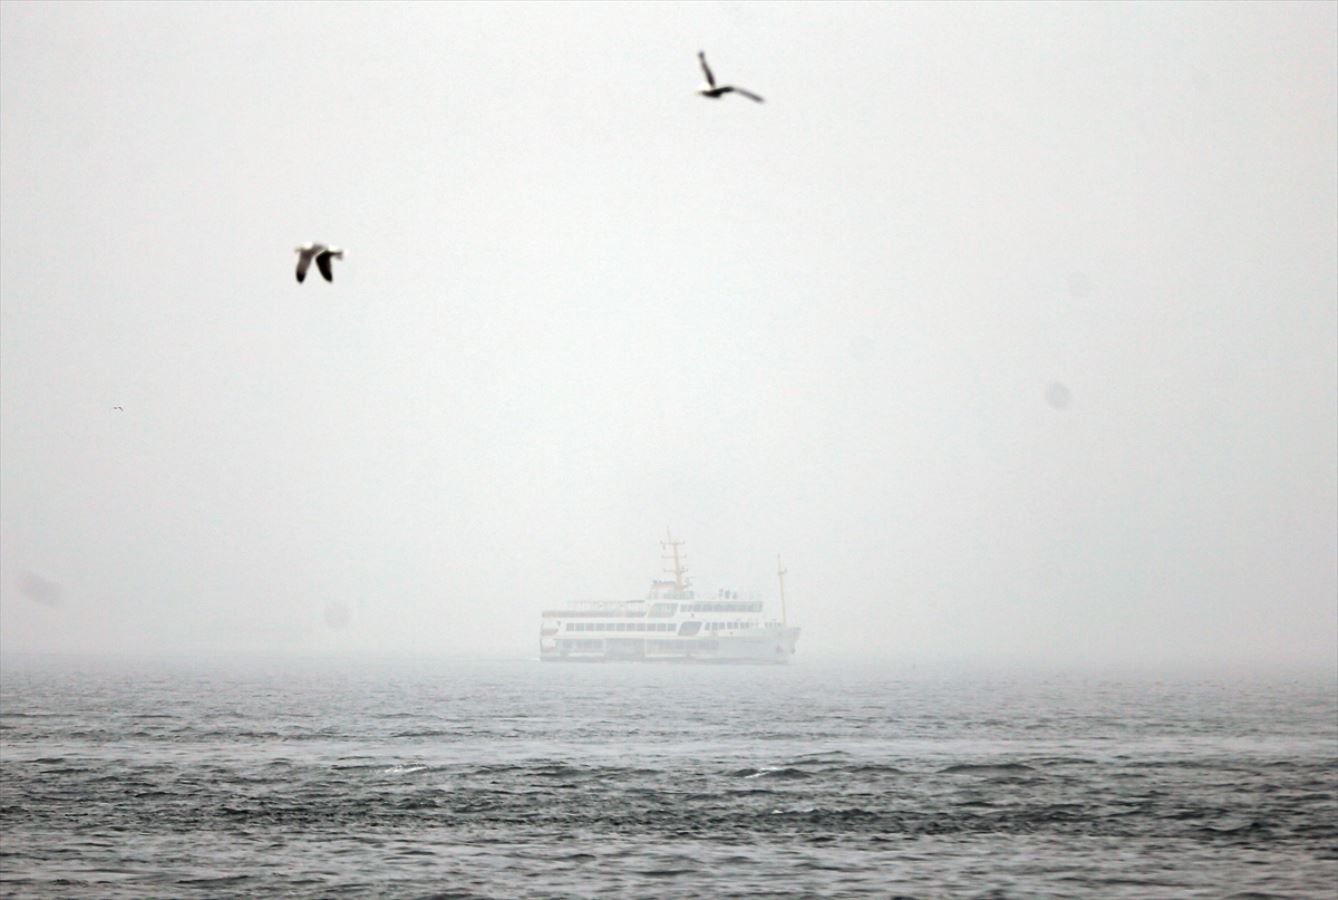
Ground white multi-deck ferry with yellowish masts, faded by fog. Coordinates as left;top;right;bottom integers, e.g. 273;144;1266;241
539;536;799;663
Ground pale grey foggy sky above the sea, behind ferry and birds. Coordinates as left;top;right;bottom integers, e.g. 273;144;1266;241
0;3;1338;665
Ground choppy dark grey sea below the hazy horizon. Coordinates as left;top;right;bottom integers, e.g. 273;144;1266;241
0;658;1338;900
